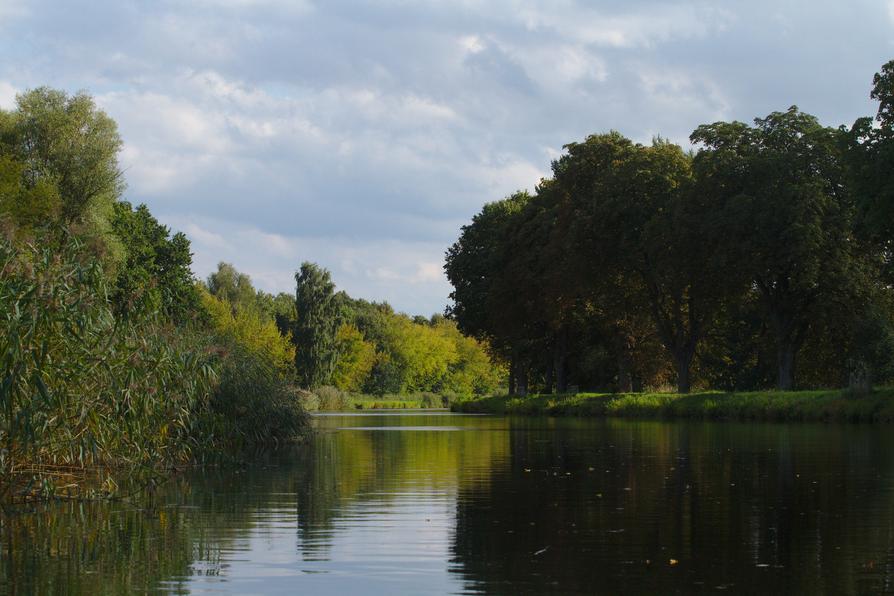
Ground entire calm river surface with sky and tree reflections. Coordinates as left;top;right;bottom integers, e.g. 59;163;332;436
0;413;894;594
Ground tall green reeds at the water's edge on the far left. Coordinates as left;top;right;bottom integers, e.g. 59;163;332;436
0;235;215;501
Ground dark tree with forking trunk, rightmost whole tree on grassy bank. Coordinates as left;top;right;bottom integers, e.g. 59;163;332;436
691;107;855;390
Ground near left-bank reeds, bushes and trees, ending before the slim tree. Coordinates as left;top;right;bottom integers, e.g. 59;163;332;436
0;88;316;503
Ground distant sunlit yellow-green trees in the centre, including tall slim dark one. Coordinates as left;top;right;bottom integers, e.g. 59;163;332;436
204;262;503;398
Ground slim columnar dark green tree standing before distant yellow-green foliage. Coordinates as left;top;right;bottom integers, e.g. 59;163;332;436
293;262;340;388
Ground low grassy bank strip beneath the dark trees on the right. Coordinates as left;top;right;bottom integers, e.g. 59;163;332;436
452;388;894;422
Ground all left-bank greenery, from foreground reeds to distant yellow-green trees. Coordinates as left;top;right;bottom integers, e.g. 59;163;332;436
0;87;499;504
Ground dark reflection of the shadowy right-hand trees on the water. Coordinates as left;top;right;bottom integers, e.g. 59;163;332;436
453;421;894;594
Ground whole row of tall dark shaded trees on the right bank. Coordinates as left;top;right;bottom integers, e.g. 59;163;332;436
445;61;894;394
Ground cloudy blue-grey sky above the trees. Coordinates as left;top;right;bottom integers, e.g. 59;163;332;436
0;0;894;315
